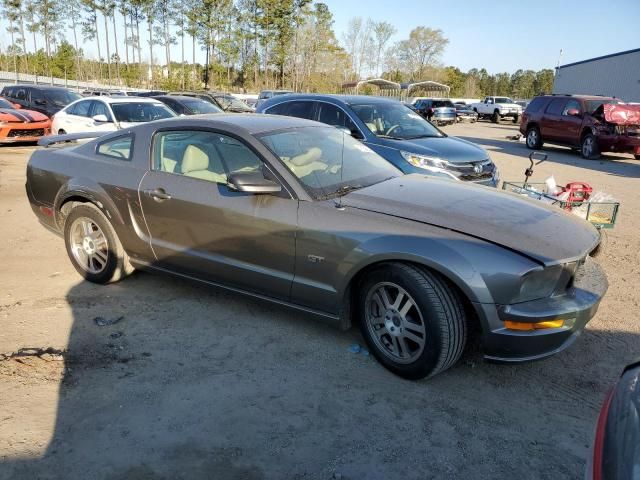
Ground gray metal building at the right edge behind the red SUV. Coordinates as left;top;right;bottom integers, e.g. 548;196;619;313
553;48;640;102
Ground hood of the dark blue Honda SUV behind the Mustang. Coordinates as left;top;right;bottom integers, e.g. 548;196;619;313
376;137;489;163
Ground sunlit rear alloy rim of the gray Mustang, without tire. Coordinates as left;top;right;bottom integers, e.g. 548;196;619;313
69;217;109;274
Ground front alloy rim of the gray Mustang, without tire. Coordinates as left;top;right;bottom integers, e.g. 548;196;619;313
365;282;426;363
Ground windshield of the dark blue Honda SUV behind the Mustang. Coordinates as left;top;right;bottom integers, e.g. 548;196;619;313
351;102;444;140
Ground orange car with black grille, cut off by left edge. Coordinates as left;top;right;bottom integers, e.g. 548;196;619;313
0;97;51;143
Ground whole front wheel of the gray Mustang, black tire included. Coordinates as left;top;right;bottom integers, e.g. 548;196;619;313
358;263;467;380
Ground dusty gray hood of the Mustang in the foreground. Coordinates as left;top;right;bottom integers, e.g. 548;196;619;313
342;174;600;266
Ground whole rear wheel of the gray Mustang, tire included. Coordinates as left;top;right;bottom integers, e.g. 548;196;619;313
64;203;134;284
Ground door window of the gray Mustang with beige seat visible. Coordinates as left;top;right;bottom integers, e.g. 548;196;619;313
153;130;262;184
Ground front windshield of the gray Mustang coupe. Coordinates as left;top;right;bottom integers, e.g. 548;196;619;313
260;127;401;200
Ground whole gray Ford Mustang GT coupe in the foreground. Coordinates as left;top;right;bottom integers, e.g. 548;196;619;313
26;115;607;379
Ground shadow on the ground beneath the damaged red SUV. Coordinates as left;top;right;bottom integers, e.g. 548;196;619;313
457;132;640;178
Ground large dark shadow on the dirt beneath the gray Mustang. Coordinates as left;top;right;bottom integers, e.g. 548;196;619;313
0;258;640;480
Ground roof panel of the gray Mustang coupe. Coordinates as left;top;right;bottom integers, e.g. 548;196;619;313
148;113;332;135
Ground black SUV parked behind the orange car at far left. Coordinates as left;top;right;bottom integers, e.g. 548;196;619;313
0;85;82;117
